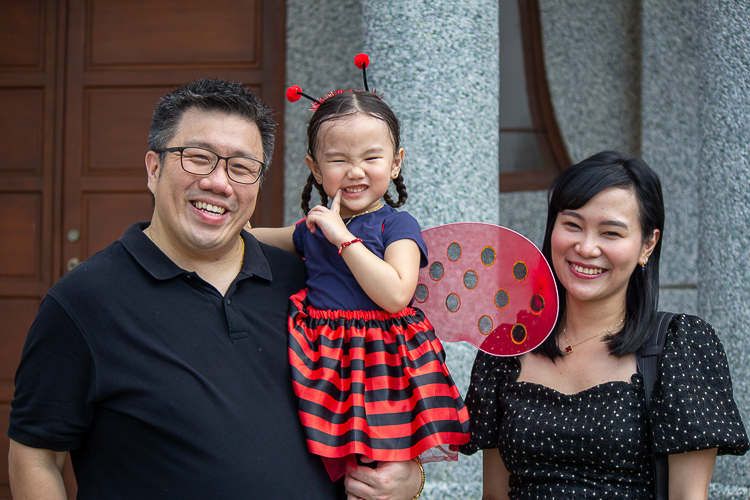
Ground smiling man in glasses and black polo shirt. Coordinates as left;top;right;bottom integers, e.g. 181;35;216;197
8;80;420;499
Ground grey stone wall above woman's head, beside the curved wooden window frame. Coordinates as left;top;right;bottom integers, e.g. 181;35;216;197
539;0;641;163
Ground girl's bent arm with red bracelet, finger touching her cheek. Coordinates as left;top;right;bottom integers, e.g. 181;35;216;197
306;191;421;313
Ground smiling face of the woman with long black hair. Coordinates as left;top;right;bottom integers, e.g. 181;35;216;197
550;187;659;307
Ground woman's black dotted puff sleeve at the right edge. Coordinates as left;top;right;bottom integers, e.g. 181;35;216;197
649;315;750;455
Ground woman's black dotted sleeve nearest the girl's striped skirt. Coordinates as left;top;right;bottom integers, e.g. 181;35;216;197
460;351;518;455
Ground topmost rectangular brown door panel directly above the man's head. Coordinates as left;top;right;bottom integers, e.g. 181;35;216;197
86;0;262;69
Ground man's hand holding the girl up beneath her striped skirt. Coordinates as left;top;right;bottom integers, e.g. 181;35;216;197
344;457;422;500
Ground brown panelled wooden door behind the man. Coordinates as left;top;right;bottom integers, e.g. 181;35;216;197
0;0;285;498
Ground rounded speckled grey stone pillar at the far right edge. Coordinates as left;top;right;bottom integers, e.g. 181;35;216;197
695;0;750;498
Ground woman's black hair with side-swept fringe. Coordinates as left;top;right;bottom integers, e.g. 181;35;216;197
535;151;664;360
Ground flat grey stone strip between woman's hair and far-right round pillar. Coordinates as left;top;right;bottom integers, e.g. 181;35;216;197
641;0;701;314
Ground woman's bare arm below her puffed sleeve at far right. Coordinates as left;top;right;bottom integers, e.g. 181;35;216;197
667;448;717;500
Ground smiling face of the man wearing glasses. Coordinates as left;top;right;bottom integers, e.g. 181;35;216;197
146;108;264;257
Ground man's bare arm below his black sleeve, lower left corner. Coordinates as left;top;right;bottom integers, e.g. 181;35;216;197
8;439;68;500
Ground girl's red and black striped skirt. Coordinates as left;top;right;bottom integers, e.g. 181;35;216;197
289;290;469;480
